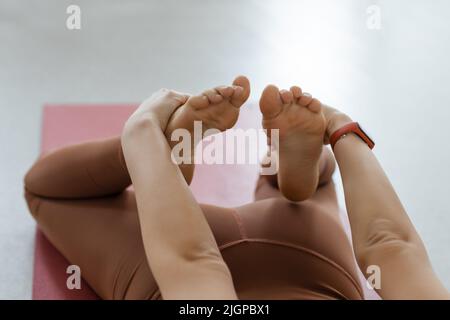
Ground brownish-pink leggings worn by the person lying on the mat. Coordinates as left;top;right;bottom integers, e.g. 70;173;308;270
25;137;363;299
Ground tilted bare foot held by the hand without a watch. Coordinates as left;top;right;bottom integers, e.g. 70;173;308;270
165;76;250;184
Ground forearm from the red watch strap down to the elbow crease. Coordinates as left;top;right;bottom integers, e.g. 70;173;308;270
334;134;426;253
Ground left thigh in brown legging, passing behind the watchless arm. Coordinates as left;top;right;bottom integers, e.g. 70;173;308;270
26;190;239;300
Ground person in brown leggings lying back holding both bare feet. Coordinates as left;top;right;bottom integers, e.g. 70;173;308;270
25;76;450;299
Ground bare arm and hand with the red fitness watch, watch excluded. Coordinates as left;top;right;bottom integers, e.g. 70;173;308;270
327;109;450;299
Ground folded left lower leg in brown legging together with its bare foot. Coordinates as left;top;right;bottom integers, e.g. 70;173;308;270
25;77;250;199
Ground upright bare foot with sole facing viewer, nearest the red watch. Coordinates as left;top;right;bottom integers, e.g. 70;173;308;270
260;85;326;201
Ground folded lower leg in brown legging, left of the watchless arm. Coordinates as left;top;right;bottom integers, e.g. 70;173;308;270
25;137;131;199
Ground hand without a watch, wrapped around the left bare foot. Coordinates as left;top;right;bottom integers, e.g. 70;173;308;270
125;89;189;131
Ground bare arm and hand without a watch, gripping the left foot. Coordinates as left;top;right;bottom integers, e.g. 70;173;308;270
122;90;236;299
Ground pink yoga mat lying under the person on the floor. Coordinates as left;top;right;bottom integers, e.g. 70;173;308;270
32;104;380;300
